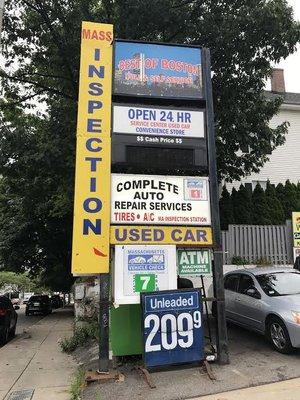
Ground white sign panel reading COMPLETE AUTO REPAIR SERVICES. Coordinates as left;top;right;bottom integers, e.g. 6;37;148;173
111;174;211;225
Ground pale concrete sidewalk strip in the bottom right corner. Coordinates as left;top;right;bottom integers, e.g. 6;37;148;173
194;378;300;400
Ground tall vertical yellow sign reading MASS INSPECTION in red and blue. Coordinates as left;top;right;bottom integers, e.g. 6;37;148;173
72;22;113;275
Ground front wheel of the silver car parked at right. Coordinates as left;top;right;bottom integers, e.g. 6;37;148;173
267;317;293;354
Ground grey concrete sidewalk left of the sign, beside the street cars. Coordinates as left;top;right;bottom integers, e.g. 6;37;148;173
0;308;77;400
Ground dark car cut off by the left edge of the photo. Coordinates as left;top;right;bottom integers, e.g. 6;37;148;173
0;296;20;345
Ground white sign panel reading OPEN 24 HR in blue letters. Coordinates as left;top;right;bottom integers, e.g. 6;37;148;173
113;105;204;140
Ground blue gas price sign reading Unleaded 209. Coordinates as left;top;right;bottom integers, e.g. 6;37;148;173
141;289;204;367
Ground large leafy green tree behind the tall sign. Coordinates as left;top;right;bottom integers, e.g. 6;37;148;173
0;0;299;286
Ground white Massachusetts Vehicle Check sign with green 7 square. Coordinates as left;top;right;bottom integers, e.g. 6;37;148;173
114;245;177;304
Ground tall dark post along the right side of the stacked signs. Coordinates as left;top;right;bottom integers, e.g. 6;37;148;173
202;49;229;364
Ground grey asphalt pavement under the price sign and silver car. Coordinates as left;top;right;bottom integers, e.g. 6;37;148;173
79;325;300;400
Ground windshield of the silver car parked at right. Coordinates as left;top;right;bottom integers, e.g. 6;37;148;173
256;271;300;297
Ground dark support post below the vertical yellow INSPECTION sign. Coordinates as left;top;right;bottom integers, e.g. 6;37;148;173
98;274;109;373
